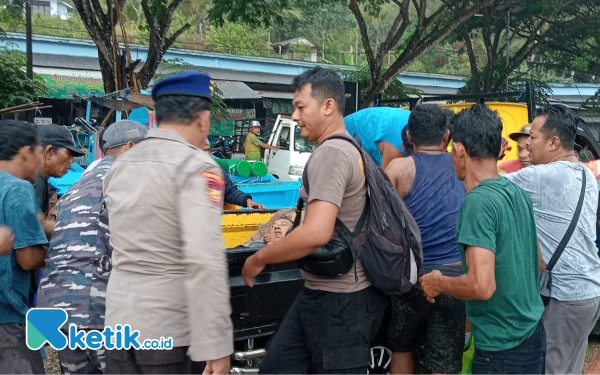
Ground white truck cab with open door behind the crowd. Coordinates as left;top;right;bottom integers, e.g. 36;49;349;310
263;115;316;181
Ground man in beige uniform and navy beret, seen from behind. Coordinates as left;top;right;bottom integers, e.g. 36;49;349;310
104;71;233;375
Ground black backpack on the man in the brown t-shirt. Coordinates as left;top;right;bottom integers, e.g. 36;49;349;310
303;134;423;295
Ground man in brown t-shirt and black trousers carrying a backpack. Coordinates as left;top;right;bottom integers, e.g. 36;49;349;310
242;68;400;375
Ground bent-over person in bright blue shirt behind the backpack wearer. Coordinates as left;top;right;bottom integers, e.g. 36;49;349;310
344;107;410;169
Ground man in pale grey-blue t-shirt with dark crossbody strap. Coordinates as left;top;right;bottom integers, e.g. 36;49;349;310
505;105;600;375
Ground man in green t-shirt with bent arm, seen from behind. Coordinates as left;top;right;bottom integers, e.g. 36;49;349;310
421;105;546;375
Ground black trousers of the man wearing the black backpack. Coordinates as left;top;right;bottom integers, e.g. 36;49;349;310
260;287;389;375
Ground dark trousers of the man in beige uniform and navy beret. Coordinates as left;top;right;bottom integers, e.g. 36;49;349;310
104;346;206;375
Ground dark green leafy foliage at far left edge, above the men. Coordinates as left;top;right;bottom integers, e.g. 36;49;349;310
0;45;48;108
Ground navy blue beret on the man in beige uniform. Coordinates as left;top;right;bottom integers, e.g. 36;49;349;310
152;70;212;101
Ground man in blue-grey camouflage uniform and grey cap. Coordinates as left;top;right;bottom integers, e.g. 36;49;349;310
38;120;148;375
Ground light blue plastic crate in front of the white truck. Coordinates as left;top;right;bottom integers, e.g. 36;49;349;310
237;180;301;209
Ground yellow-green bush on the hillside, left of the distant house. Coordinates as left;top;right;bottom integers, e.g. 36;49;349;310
206;22;275;56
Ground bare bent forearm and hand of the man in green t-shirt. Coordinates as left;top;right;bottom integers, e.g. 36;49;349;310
421;246;496;301
